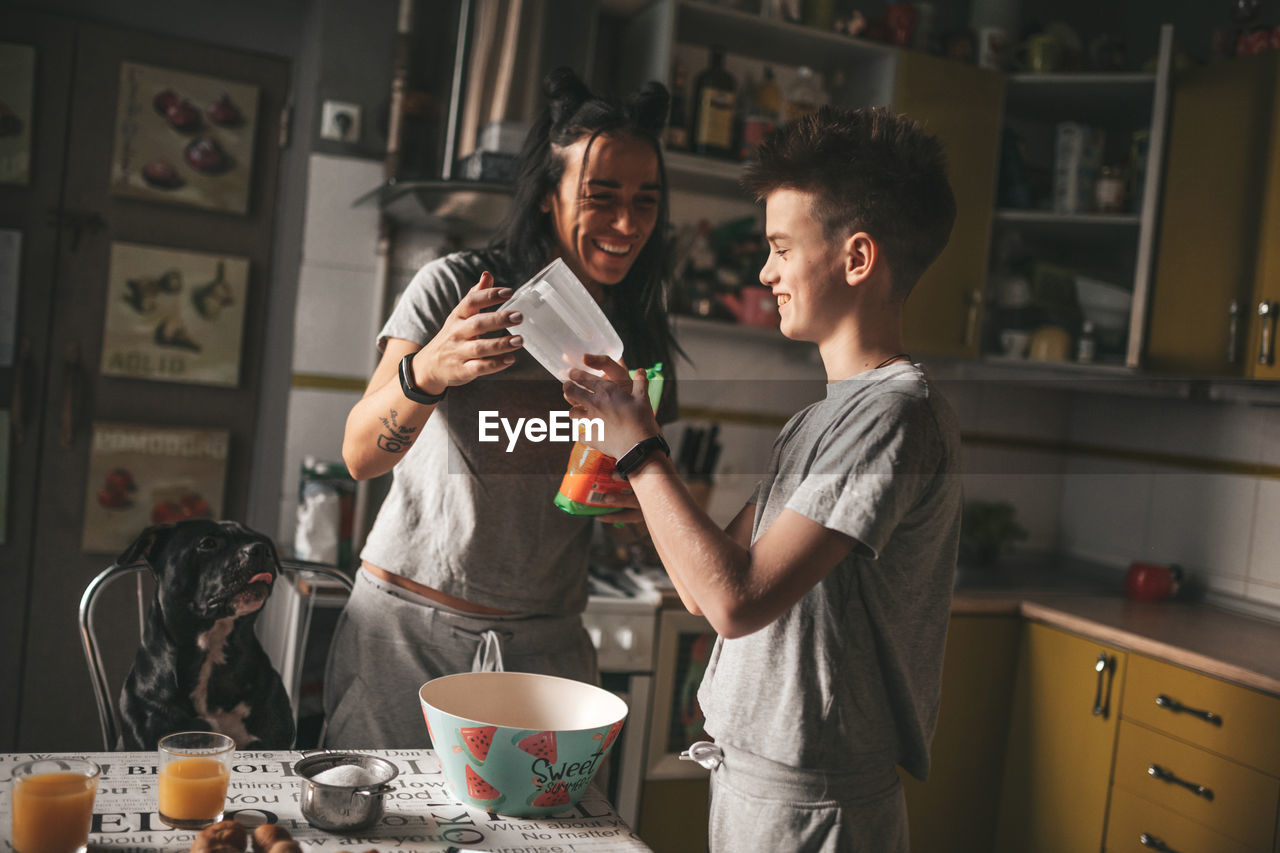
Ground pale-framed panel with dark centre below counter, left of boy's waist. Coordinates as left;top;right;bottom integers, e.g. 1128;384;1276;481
645;610;716;779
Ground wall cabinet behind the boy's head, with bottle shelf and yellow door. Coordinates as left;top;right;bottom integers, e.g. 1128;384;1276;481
617;0;1004;357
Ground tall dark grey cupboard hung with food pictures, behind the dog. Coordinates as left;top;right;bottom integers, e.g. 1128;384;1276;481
0;6;289;751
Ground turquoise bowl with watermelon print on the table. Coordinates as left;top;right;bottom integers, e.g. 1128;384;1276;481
417;672;627;817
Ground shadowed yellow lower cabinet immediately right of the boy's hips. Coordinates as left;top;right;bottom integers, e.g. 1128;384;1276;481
900;615;1021;853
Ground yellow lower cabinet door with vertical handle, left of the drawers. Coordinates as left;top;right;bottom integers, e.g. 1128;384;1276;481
993;622;1125;853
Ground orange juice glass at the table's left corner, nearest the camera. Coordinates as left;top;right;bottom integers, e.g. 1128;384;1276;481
13;758;99;853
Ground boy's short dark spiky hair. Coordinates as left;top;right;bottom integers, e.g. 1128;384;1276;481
742;106;956;300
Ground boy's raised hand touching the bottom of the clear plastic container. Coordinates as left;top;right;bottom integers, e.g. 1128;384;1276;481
563;355;662;459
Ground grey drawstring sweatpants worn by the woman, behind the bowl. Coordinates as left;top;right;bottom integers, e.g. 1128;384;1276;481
321;571;599;749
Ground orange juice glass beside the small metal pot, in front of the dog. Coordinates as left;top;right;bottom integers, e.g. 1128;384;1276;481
159;731;236;829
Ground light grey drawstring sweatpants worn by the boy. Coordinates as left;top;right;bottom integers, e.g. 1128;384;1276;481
708;747;910;853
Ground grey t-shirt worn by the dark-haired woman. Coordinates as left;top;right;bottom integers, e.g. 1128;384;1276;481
361;252;590;615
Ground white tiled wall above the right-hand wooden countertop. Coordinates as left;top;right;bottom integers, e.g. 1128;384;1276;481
941;380;1280;616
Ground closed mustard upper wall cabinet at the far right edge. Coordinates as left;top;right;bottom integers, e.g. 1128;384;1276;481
1147;51;1280;379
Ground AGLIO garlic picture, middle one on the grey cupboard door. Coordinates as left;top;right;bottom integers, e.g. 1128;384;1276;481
101;242;248;387
